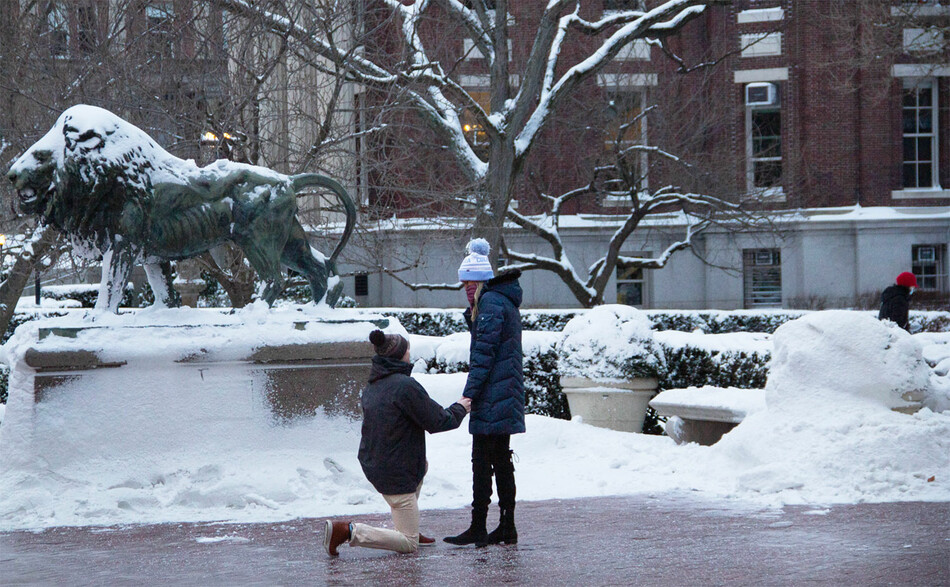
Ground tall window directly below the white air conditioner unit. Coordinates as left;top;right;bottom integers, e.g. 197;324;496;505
746;99;782;195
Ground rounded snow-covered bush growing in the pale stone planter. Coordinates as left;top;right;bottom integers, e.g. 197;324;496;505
557;304;661;381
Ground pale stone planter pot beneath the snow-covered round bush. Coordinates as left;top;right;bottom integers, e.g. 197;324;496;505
561;377;657;432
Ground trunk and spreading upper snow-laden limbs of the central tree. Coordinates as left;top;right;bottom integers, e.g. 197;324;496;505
205;0;730;256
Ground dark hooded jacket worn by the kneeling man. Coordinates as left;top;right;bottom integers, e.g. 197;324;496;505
359;355;465;495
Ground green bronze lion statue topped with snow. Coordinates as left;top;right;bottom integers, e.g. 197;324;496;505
8;105;356;312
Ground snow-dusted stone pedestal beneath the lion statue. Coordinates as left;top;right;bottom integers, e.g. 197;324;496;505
23;320;386;424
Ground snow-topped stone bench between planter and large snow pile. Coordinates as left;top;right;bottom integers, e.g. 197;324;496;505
650;387;765;446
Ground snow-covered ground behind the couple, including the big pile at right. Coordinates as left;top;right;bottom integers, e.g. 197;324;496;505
0;311;950;530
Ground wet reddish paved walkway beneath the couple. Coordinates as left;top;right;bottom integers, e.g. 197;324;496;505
0;495;950;587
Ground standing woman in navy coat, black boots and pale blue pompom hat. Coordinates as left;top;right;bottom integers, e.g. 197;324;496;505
445;238;525;546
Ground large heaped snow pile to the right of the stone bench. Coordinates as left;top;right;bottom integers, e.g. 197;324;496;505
710;311;950;503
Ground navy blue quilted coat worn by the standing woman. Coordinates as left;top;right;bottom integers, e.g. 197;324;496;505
462;270;525;434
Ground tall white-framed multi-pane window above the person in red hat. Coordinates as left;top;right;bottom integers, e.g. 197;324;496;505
902;78;940;189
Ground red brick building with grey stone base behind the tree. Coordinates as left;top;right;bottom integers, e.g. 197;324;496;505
344;0;950;308
